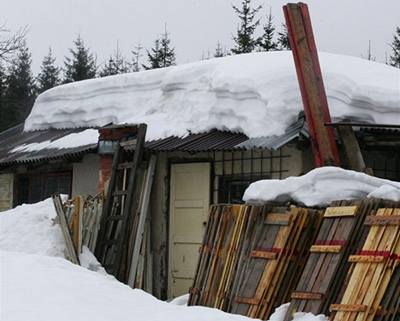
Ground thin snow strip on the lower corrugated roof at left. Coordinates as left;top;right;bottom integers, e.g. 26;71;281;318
10;129;99;153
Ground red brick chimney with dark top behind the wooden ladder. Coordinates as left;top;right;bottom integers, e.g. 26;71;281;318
97;125;138;193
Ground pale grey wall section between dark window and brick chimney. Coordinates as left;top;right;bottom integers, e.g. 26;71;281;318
72;154;100;196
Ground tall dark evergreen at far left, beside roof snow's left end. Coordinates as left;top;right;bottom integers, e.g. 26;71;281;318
3;42;36;127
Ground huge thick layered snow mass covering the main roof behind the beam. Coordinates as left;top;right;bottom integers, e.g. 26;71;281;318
25;51;400;139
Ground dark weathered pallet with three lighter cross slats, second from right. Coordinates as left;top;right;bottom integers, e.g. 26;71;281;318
285;200;386;321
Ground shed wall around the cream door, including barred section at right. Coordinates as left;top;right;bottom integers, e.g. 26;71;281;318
150;145;304;299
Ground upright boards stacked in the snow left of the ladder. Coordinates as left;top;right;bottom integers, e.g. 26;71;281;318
53;193;104;264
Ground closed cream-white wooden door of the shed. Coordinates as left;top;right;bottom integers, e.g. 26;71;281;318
169;163;210;297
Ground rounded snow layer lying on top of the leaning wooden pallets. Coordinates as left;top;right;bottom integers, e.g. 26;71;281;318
243;166;400;206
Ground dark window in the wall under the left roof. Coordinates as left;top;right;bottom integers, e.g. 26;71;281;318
16;172;72;205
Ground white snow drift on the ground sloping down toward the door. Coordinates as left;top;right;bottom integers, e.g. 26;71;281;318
0;199;327;321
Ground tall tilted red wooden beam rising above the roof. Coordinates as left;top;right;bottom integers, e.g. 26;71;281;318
283;2;340;167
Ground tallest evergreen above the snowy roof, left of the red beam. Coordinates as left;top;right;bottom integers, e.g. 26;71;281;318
232;0;262;54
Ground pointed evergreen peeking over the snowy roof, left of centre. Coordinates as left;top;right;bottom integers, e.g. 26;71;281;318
142;30;175;70
